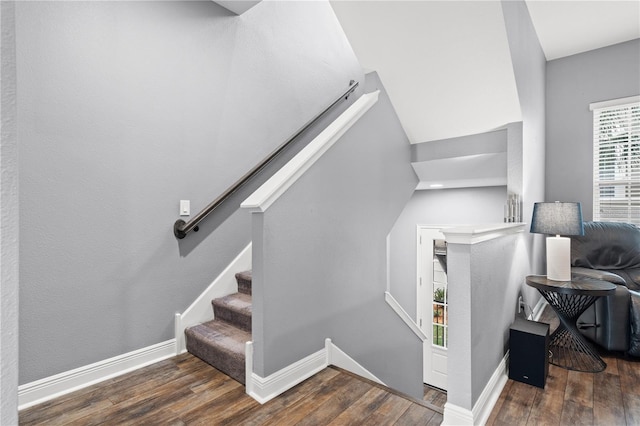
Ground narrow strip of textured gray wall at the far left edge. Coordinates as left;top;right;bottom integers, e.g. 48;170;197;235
0;1;18;425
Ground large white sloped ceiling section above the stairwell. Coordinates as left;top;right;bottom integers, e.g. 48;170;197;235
331;1;521;143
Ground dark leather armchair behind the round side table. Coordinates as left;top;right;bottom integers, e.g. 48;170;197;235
571;222;640;356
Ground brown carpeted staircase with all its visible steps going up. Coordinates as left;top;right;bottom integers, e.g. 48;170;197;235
185;271;251;384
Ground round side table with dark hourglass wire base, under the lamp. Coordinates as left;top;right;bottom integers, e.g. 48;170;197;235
526;275;616;373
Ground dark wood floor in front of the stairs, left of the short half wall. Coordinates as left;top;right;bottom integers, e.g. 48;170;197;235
20;354;443;426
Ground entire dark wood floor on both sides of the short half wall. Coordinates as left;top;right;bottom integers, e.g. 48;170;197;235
25;304;640;426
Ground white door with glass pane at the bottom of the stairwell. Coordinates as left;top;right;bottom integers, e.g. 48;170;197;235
416;226;449;390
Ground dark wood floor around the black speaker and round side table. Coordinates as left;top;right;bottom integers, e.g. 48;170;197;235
487;307;640;426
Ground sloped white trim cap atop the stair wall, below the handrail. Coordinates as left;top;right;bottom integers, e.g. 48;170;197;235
240;90;380;212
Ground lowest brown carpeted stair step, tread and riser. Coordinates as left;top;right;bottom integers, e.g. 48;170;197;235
185;319;251;384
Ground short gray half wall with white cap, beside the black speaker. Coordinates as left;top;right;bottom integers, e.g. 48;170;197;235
447;234;527;410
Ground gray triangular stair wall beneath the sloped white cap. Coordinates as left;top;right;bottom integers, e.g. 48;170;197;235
253;74;422;397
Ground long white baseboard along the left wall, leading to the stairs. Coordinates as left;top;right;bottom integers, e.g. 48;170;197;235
18;339;176;410
